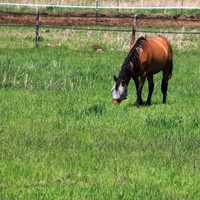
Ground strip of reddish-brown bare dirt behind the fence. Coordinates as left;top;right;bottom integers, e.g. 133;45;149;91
0;13;200;28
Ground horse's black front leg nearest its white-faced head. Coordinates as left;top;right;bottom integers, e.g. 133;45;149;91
134;76;145;106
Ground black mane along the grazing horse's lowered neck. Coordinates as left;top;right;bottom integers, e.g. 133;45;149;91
118;36;146;83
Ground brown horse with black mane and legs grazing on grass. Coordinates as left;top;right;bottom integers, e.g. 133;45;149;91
112;36;173;106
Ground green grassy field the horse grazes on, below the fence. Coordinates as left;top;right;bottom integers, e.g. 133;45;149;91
0;27;200;200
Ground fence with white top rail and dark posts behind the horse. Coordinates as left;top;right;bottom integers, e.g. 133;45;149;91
0;0;200;47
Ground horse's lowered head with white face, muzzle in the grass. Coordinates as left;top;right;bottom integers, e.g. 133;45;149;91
112;76;128;104
